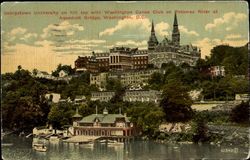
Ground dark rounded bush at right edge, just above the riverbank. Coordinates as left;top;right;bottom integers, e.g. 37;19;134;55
230;101;250;123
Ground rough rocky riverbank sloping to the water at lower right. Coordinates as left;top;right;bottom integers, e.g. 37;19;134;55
142;124;250;147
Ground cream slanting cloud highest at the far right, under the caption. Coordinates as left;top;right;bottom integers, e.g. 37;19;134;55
205;12;247;31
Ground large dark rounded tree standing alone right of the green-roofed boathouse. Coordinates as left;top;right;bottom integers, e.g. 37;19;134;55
160;81;193;122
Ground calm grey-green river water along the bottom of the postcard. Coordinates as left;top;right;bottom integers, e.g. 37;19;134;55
2;136;248;160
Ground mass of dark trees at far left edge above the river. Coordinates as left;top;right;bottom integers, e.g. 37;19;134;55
1;66;50;130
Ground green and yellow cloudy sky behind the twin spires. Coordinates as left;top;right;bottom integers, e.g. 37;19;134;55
1;1;249;73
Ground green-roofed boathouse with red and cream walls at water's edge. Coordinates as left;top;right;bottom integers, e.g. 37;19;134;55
73;108;137;137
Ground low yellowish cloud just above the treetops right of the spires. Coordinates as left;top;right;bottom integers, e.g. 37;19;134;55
194;37;248;58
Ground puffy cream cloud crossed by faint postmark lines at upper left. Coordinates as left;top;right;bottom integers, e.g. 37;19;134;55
41;21;84;40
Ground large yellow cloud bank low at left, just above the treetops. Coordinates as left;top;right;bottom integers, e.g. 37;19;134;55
1;41;77;73
